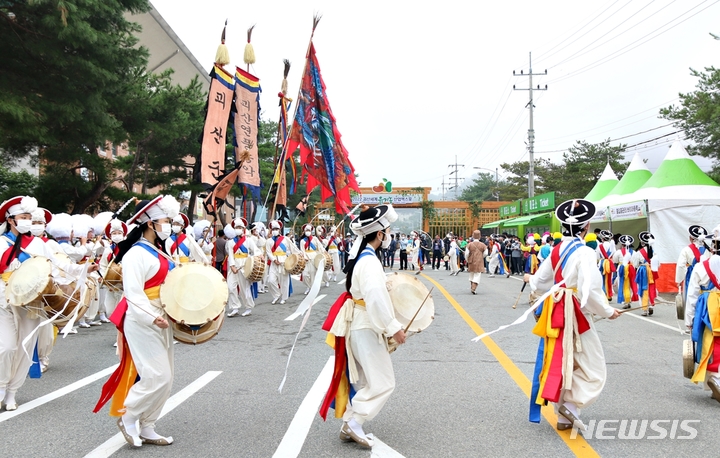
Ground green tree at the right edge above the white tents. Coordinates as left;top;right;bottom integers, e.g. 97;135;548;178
660;67;720;181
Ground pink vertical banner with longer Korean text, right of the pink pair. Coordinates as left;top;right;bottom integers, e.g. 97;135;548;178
233;68;262;200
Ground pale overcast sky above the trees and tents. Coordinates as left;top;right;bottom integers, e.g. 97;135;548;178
152;0;720;196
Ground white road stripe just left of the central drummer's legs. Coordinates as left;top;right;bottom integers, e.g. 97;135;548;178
273;356;335;458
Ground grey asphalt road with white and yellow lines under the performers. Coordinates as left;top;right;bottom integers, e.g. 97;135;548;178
0;270;720;457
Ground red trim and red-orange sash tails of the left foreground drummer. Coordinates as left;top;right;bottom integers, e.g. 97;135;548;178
93;243;175;417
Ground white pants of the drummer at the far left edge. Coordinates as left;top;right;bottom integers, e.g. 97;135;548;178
0;305;41;394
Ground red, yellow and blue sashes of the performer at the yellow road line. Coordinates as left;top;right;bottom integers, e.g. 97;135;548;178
529;239;590;423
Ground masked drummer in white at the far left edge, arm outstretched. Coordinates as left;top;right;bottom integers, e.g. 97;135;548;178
0;196;97;410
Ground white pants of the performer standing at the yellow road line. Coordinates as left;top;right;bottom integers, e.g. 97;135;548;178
560;313;607;408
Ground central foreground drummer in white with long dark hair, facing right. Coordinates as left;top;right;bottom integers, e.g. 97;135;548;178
328;205;406;448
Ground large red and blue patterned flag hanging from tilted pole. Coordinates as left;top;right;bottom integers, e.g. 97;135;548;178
286;16;359;214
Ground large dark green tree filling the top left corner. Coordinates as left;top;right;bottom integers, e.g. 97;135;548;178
0;0;149;212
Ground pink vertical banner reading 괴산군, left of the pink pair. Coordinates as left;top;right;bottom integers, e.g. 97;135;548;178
200;65;235;186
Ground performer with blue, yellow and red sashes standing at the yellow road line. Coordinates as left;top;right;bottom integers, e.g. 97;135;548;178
525;199;620;430
